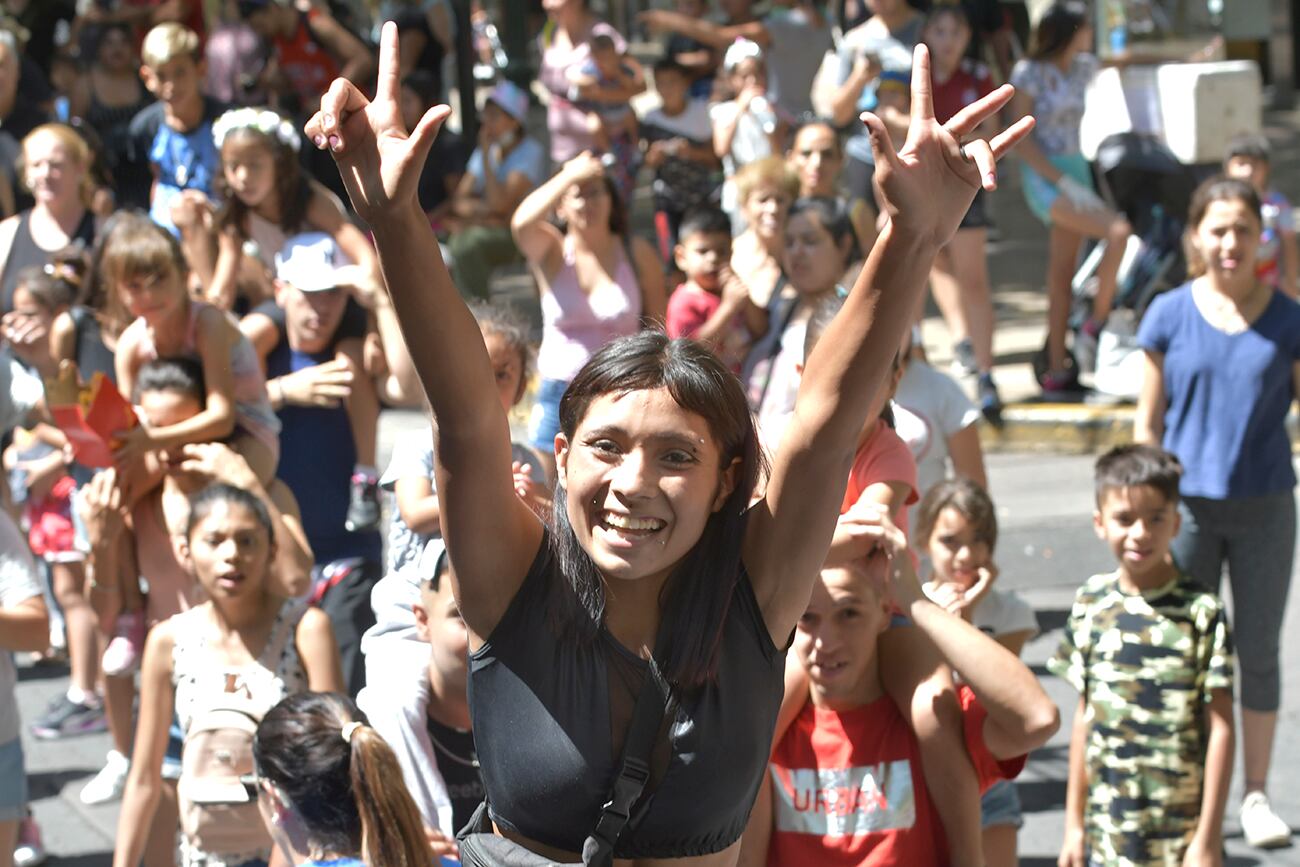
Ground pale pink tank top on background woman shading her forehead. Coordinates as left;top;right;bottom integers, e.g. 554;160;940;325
537;237;641;382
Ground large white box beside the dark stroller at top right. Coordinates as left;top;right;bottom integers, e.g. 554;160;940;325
1080;60;1264;165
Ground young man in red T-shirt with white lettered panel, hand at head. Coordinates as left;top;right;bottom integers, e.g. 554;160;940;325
741;535;1060;867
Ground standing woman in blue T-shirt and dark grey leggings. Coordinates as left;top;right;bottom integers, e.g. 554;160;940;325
1134;178;1300;846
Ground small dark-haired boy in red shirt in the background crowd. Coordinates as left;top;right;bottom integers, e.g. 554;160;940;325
666;208;767;373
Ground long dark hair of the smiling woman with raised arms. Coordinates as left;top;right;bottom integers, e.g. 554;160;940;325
550;330;763;689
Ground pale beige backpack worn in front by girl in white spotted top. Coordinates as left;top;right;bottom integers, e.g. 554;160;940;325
177;675;272;855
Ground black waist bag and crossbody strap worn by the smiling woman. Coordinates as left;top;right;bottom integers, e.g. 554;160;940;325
456;659;672;867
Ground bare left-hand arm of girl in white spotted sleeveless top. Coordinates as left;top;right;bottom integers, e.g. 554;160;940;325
113;623;174;867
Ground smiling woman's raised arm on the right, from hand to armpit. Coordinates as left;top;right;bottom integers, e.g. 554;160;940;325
744;45;1034;643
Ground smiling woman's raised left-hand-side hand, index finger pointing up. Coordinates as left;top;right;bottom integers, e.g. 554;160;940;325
306;21;451;225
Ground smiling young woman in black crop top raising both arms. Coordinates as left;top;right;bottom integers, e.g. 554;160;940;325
307;25;1032;866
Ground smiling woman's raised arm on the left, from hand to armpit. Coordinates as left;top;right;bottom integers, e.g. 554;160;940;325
307;22;542;638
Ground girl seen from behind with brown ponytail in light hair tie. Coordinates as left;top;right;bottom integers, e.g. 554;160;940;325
252;693;434;867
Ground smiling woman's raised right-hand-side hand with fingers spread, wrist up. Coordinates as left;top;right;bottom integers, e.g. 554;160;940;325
862;44;1034;246
